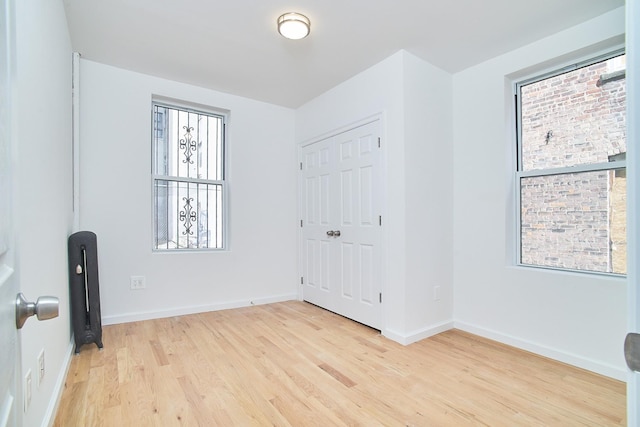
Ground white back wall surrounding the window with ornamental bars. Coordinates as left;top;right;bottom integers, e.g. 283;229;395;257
80;60;299;324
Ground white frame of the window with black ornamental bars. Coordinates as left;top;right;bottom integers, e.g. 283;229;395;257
149;96;231;254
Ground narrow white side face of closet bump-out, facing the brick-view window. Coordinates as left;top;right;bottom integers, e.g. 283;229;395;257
402;54;454;336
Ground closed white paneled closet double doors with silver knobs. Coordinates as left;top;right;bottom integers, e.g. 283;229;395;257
301;120;382;329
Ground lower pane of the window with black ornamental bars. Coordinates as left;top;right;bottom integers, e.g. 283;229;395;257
154;180;224;249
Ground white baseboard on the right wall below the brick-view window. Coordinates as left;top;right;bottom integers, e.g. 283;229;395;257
453;321;627;382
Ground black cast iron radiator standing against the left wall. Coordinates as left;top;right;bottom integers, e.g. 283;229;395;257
69;231;102;354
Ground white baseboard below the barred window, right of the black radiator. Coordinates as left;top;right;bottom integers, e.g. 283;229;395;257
102;293;298;325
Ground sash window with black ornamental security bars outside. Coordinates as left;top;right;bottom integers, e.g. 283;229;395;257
152;102;226;250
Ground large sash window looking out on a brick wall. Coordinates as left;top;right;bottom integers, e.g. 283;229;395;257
516;52;627;274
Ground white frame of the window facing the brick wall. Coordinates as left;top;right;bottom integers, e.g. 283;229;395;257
513;48;628;277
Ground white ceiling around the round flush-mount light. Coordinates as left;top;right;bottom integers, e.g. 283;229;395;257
64;0;624;107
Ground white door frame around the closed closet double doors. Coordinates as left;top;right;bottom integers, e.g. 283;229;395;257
296;112;389;335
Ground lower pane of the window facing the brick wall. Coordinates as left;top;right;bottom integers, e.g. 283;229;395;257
520;169;627;274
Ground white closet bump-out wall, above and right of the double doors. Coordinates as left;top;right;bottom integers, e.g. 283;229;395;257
296;51;453;343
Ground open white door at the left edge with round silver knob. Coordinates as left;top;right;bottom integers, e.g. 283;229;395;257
0;0;22;427
